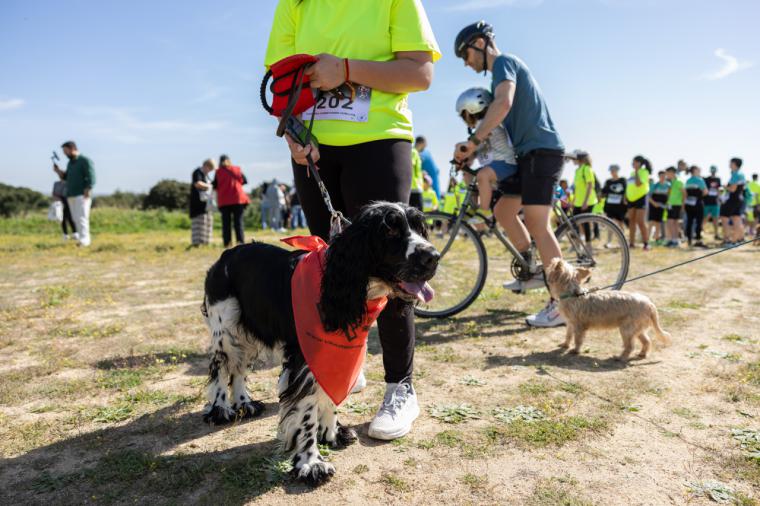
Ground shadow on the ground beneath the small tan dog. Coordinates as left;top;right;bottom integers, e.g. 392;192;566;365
484;347;660;372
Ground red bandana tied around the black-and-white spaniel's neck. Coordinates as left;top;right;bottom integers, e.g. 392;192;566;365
282;236;388;405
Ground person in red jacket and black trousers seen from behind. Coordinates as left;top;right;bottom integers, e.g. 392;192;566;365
213;155;249;248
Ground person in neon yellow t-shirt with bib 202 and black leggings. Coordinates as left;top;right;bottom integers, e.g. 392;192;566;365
264;0;441;444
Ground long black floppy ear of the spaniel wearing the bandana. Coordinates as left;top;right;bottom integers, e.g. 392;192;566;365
319;223;373;333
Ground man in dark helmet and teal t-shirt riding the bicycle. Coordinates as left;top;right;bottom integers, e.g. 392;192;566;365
454;21;565;327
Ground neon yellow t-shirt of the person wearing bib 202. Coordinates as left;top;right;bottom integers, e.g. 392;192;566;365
264;0;441;146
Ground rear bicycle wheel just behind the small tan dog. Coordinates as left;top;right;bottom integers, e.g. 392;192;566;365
555;214;631;290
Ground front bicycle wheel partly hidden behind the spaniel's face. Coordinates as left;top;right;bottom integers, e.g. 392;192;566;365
414;211;488;318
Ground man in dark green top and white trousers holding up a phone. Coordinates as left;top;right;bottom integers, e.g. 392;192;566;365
53;141;95;246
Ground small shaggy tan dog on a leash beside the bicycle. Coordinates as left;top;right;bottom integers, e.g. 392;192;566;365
546;258;670;360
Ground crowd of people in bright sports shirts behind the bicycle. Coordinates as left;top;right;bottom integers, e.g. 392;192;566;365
556;151;760;250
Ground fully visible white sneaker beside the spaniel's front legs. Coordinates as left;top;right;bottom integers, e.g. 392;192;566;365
368;383;420;441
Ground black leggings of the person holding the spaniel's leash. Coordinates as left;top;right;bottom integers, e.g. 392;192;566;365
292;139;414;383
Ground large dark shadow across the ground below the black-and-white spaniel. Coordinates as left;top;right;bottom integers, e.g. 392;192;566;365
0;403;314;504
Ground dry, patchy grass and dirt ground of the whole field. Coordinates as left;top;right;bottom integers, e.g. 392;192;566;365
0;214;760;505
